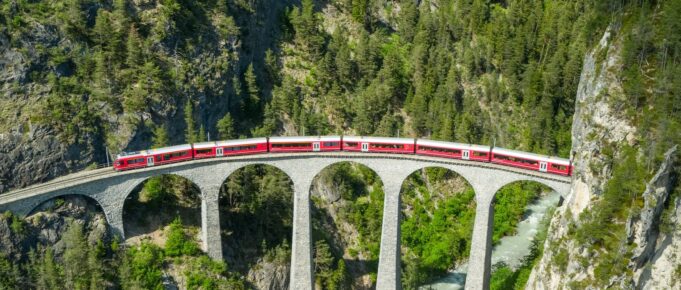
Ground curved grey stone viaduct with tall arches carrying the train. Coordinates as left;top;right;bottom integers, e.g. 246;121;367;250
0;152;571;289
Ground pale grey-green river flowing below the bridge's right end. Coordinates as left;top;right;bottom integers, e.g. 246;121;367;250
420;192;560;290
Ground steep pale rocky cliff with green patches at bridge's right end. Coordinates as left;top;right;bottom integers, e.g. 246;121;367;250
526;23;681;289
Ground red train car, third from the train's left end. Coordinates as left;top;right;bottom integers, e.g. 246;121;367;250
269;136;341;152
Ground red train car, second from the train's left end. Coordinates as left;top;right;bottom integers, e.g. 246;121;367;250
194;138;267;159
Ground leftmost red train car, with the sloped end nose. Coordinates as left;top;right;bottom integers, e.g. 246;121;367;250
114;144;194;171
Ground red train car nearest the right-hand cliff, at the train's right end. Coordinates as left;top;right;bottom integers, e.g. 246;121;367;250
492;147;572;175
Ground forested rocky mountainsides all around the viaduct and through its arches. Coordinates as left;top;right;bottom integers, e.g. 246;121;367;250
0;0;681;289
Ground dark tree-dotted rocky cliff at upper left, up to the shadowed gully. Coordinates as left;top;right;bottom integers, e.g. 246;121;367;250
0;0;291;193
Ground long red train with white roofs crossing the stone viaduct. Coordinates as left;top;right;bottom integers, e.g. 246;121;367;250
114;136;572;176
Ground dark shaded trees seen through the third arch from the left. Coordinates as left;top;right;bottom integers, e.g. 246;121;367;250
220;165;293;265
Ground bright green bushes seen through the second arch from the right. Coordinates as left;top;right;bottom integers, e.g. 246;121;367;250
401;168;475;289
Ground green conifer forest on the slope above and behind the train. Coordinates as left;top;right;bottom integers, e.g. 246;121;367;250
0;0;616;156
